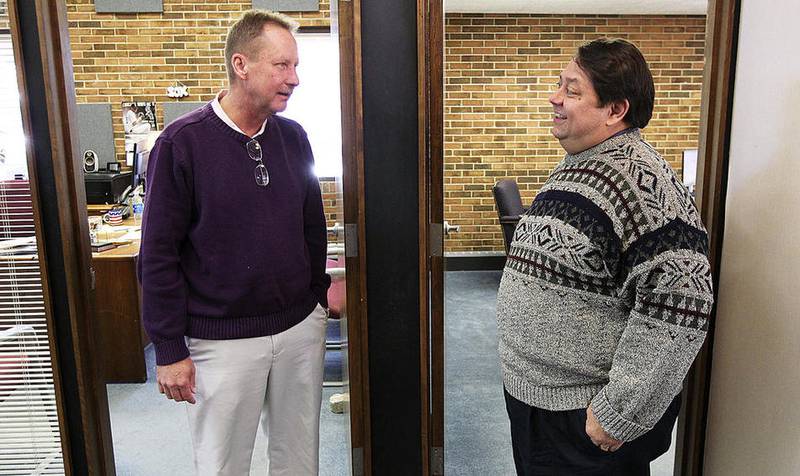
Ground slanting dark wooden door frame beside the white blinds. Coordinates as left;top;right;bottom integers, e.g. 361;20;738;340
8;0;114;474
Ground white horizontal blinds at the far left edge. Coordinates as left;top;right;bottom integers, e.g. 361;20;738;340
0;35;64;475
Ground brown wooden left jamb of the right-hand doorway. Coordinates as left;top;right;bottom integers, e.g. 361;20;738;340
417;0;444;475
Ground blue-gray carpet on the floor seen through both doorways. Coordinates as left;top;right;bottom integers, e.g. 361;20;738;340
108;271;674;476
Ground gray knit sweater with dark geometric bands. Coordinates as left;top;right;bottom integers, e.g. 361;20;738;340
497;129;713;441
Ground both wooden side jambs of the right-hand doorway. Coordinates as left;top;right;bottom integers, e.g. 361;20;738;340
417;0;741;476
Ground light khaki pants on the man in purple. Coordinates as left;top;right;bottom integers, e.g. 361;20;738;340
187;305;327;476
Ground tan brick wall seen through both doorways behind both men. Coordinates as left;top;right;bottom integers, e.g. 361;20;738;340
59;6;705;245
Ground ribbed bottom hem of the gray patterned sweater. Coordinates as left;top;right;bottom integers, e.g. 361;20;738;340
503;373;605;411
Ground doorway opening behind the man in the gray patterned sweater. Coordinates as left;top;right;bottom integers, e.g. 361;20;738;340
443;1;706;475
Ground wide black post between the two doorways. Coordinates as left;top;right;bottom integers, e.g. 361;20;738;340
360;1;427;475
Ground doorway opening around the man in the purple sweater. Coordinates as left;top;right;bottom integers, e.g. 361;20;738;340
56;1;363;474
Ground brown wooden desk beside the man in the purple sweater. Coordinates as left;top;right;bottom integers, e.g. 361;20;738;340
92;223;150;383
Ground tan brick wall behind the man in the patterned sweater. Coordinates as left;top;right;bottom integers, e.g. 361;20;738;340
444;14;705;252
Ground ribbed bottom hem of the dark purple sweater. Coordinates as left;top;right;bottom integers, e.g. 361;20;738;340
186;292;318;340
